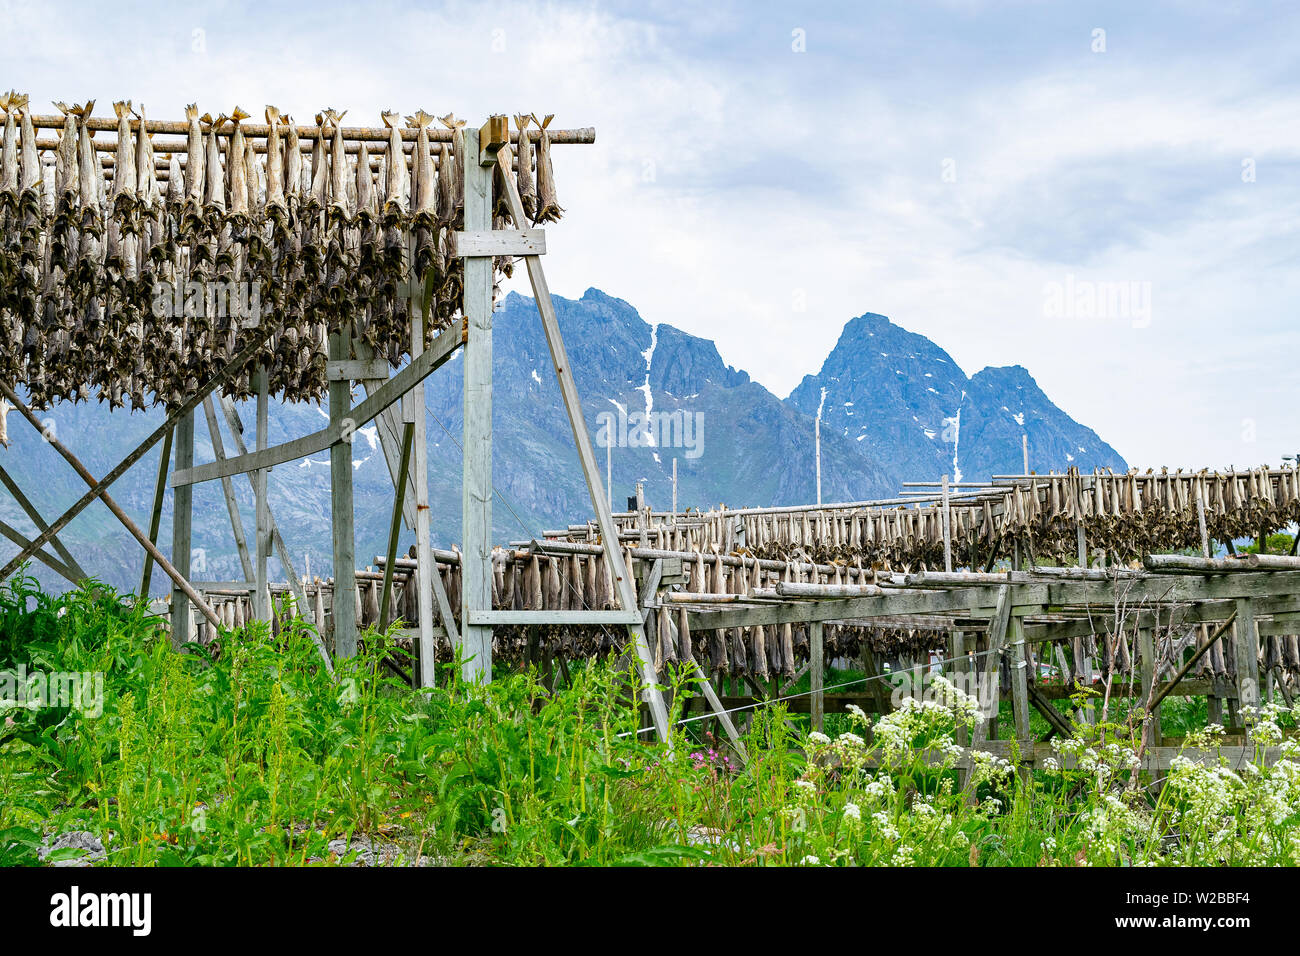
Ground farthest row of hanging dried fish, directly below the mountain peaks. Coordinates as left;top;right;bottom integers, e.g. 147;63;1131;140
595;467;1300;570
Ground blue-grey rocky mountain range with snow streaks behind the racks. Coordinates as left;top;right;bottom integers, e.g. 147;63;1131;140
0;289;1125;593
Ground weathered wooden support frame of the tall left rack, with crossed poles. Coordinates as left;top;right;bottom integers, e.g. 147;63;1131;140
0;116;733;741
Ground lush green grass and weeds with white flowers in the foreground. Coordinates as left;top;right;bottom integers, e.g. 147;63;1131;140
0;578;1300;866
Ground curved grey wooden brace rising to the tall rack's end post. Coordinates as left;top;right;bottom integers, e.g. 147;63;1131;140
172;328;462;488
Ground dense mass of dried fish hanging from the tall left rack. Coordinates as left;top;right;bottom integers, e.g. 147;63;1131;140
0;92;563;408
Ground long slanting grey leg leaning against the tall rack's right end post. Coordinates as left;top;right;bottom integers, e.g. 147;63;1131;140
488;149;671;743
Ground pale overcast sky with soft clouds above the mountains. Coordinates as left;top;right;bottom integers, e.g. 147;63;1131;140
10;0;1300;467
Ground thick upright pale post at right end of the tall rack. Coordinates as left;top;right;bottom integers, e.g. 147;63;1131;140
460;129;493;682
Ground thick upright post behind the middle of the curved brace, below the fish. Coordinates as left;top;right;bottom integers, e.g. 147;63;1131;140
329;325;356;658
